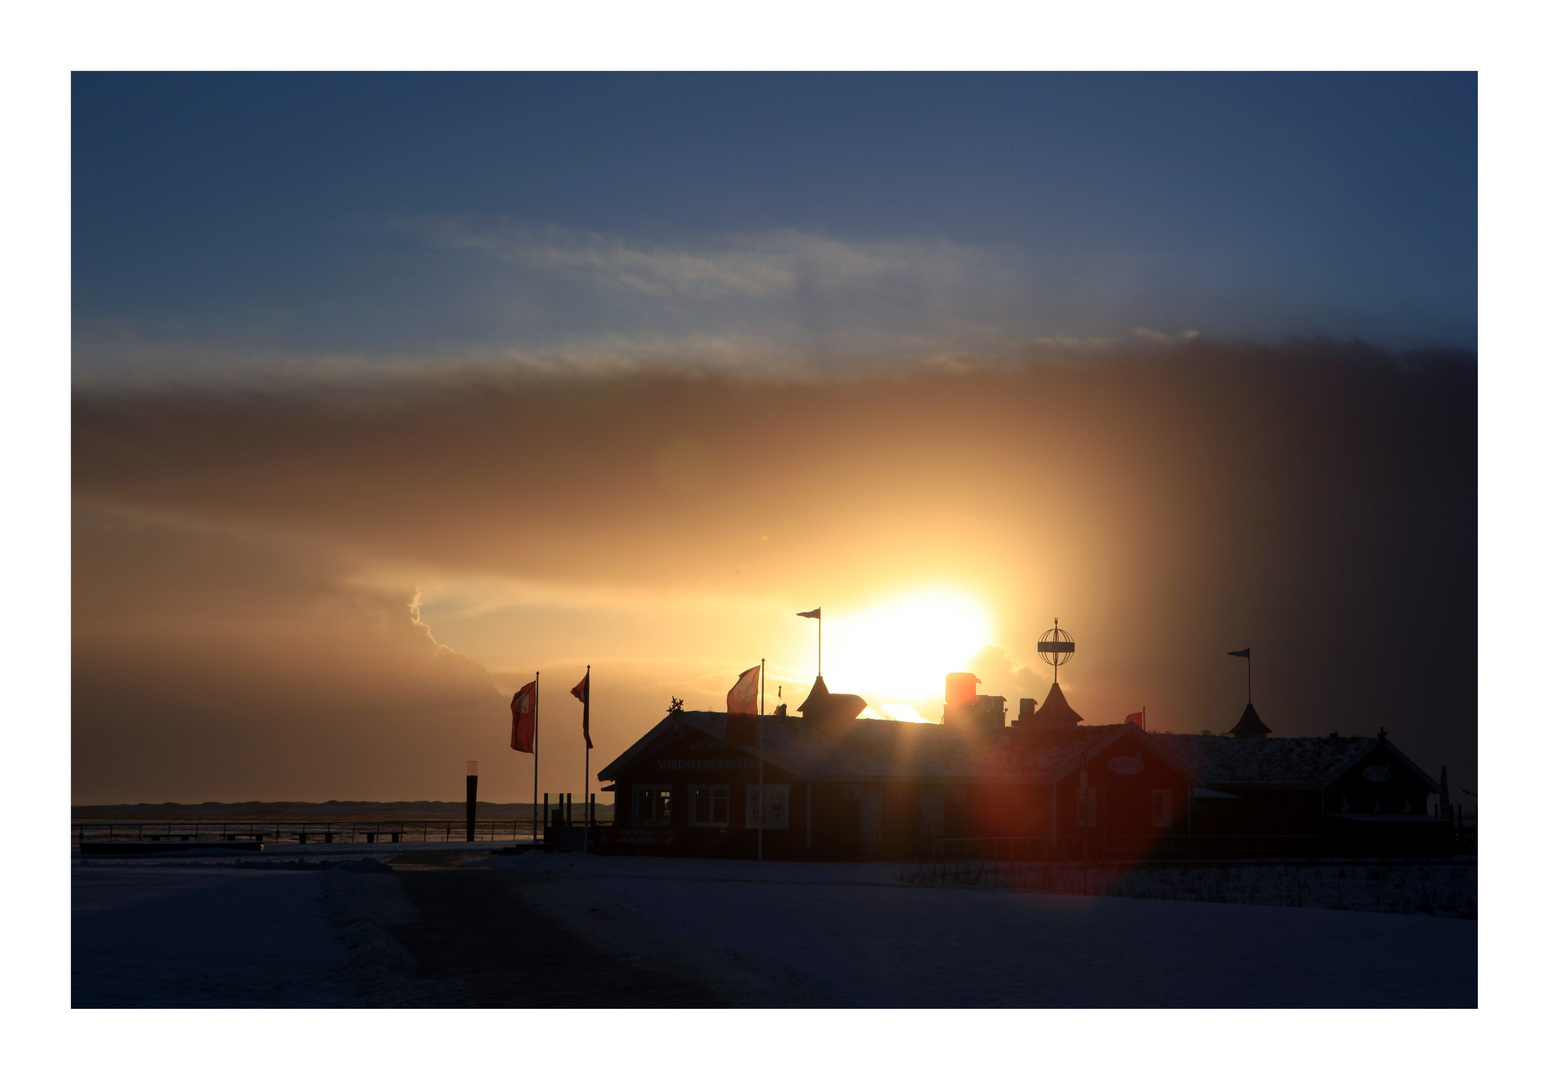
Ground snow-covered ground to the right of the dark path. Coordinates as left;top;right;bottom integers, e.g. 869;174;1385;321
502;854;1478;1007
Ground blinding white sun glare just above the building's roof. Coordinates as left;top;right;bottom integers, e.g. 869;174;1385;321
823;592;993;719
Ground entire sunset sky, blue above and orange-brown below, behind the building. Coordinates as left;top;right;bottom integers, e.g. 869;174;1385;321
71;73;1479;804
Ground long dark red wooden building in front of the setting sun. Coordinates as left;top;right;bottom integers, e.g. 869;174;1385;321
598;686;1445;858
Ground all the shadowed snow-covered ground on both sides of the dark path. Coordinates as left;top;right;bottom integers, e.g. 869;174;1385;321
71;844;1478;1007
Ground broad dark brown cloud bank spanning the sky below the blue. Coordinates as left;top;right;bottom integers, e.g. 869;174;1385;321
73;342;1478;801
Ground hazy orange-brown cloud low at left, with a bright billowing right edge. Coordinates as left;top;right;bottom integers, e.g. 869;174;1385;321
71;511;500;803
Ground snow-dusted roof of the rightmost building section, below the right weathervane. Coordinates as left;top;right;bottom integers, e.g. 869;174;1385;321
1148;731;1441;790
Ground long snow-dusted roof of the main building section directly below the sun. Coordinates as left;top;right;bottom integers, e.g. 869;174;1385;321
598;711;1193;782
